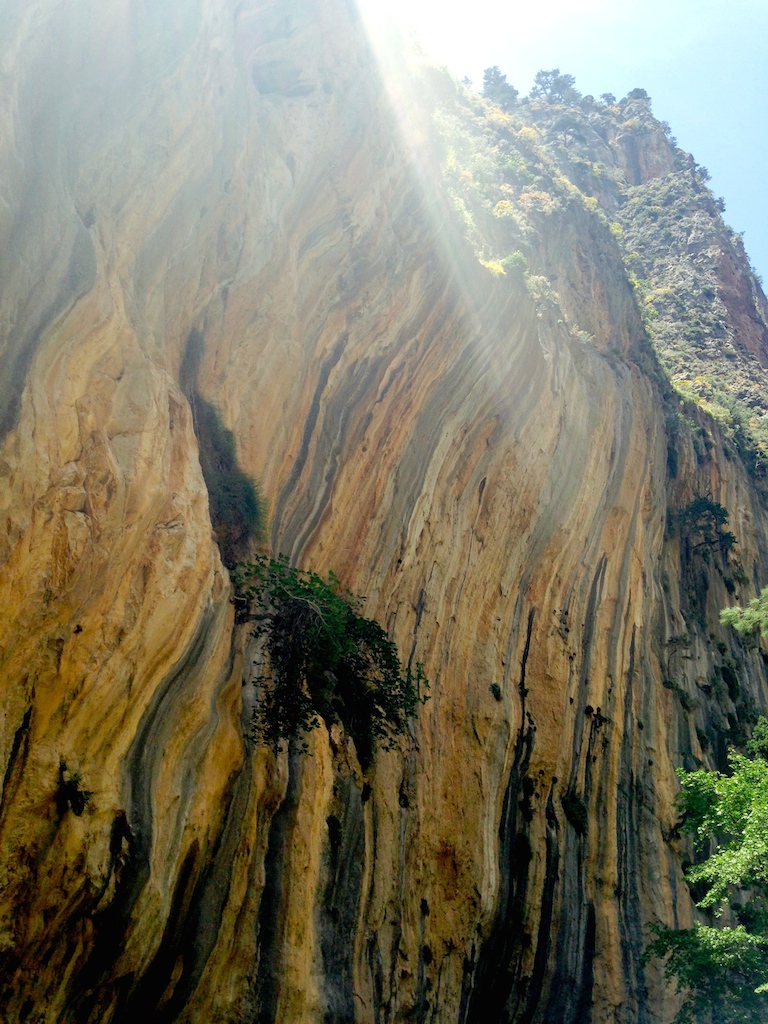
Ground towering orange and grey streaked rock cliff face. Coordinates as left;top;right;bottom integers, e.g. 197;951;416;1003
0;0;768;1024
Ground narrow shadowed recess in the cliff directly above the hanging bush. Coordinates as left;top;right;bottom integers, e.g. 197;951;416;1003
179;331;266;568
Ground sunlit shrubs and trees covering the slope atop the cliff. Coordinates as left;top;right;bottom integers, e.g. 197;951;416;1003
421;59;768;479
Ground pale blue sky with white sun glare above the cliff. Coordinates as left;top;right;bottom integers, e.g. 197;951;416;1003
382;0;768;285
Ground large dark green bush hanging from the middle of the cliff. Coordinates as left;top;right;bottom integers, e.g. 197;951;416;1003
236;556;428;763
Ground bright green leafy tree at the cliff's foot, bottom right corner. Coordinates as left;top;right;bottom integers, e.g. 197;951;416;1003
644;718;768;1024
